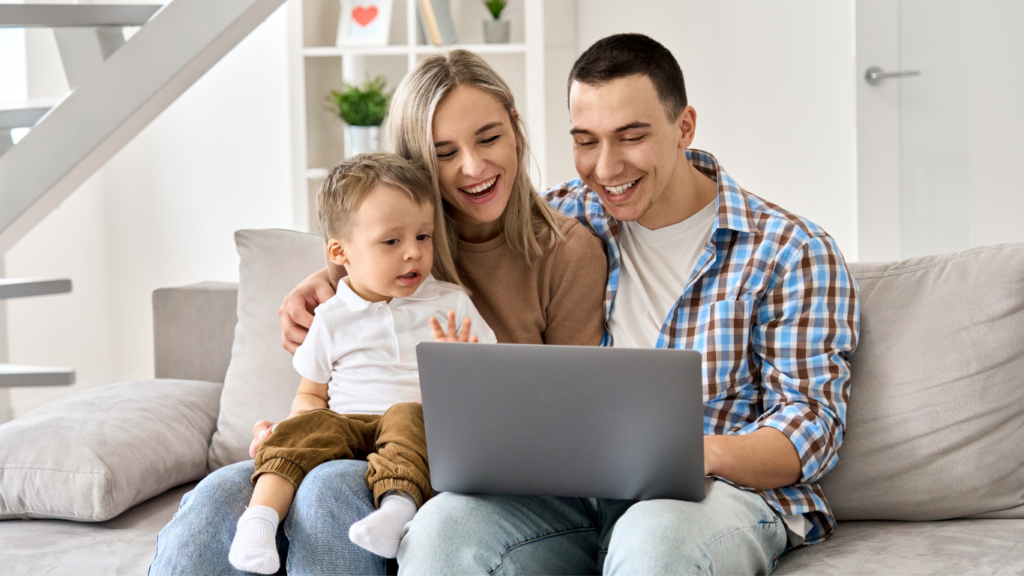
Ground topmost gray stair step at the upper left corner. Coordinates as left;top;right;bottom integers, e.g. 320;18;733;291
0;4;163;28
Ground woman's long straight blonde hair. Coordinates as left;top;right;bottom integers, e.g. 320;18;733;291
383;49;565;262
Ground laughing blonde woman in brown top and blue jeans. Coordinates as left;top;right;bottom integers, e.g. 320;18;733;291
151;50;607;575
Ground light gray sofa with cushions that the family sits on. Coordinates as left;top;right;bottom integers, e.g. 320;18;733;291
0;231;1024;575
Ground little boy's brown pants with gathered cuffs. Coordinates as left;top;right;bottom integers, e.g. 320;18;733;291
258;403;432;507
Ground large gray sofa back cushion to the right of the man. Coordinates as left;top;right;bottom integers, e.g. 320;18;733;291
821;244;1024;521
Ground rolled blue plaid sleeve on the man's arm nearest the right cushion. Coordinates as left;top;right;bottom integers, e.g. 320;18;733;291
741;230;859;484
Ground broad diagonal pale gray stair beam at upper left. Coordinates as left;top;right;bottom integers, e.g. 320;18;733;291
0;0;284;253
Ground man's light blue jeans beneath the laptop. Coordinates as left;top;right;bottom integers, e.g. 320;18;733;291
398;482;786;575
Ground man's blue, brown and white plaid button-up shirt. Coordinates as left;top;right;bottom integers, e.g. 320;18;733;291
544;150;860;544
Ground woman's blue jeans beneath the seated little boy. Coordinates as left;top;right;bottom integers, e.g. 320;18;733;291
150;460;385;576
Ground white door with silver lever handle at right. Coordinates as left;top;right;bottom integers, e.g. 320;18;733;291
857;0;1024;260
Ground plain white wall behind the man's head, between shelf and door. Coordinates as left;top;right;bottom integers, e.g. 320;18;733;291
577;0;857;255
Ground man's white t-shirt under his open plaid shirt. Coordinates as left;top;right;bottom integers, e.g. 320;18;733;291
608;202;718;348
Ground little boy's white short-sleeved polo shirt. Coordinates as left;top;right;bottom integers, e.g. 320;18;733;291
292;276;498;414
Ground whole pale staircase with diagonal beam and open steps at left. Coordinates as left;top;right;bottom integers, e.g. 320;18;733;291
0;0;284;387
